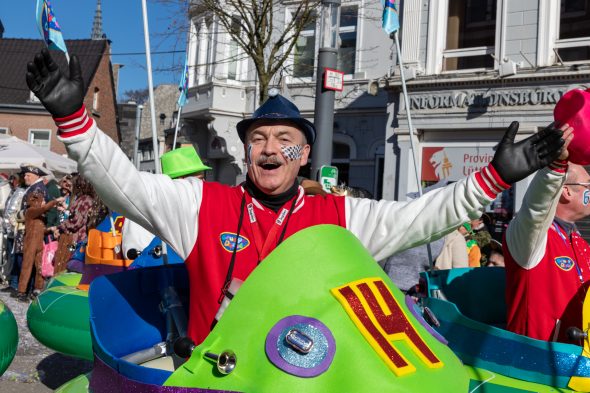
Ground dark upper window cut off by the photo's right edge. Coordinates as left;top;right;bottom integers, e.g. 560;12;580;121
555;0;590;62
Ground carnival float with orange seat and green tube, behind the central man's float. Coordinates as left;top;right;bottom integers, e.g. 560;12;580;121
27;214;183;360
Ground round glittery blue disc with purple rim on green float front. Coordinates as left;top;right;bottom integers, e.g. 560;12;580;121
266;315;336;378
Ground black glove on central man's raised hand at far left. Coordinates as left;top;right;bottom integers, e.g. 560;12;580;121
27;49;84;117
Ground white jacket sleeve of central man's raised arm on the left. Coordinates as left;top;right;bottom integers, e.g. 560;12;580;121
58;115;203;259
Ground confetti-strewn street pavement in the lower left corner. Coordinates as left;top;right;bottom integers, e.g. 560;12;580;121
0;284;92;393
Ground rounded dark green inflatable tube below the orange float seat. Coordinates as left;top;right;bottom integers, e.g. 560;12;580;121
27;286;93;360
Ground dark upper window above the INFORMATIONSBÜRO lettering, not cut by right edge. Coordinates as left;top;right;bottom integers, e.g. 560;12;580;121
443;0;497;71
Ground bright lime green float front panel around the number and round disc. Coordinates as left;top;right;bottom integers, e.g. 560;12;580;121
165;225;470;393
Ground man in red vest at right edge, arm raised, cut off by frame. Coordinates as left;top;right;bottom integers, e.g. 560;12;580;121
504;137;590;343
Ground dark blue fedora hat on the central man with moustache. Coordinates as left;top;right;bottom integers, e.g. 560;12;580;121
236;94;315;145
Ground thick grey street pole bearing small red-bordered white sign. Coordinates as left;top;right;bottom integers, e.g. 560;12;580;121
311;0;344;180
